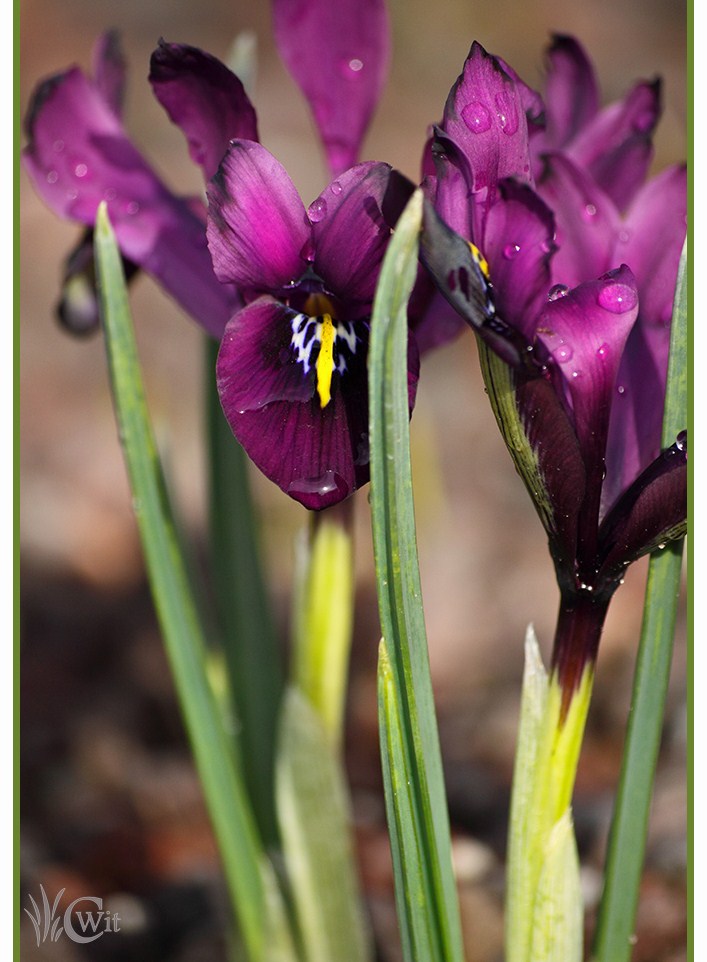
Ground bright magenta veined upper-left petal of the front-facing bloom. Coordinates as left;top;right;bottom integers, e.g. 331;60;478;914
207;140;312;292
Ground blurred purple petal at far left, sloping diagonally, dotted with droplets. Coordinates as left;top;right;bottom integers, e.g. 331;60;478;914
24;68;238;336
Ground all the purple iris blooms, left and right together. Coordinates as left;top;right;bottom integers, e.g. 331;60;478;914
25;0;686;603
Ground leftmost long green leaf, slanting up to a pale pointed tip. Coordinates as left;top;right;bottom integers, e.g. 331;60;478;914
95;205;294;962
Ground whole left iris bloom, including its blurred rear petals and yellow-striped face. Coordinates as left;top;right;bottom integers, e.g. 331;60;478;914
25;0;396;508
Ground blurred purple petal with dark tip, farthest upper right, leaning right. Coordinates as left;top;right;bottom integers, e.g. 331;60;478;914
567;81;661;210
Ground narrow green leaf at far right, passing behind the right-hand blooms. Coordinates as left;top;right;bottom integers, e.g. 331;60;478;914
592;240;687;962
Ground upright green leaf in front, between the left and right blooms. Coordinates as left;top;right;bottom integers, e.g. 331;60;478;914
369;191;462;962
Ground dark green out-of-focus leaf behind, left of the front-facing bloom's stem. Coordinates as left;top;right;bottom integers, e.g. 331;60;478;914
204;338;283;846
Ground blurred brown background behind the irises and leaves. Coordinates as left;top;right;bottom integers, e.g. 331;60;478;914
20;0;686;962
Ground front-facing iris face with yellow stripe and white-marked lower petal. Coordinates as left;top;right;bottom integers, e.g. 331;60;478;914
208;140;418;509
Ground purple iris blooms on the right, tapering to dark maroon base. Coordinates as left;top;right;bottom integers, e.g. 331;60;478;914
423;38;687;697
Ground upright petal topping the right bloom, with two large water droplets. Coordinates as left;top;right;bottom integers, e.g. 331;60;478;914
442;43;530;228
